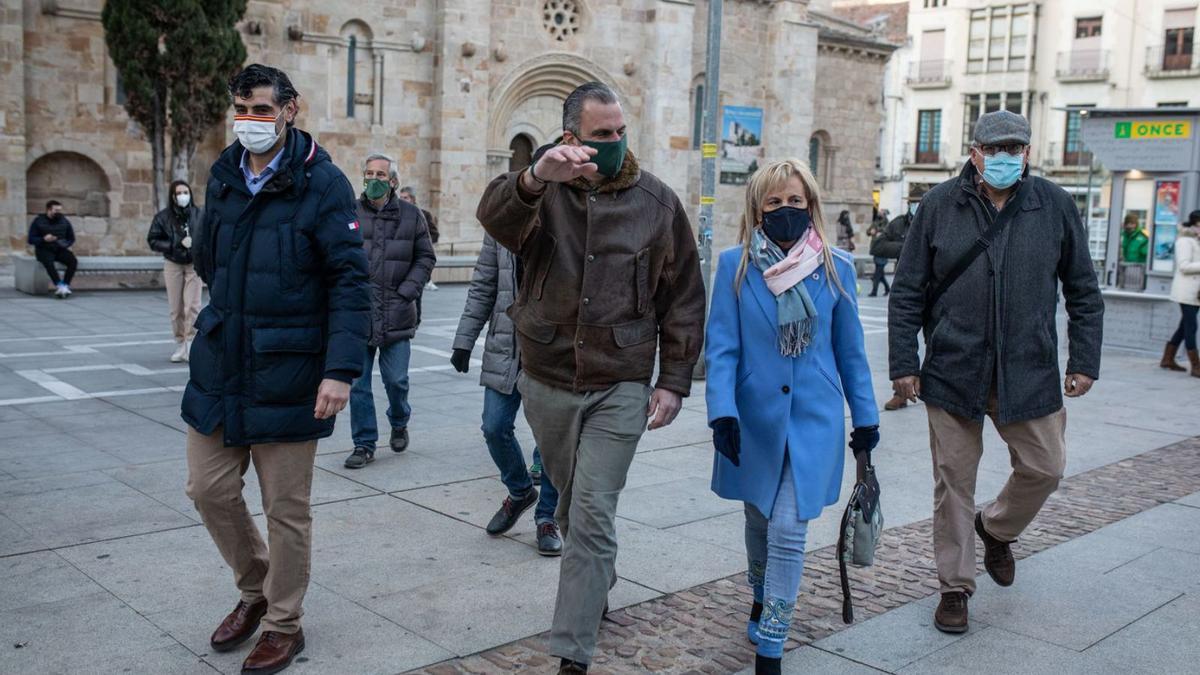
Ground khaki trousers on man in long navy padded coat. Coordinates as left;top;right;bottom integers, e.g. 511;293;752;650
187;428;317;633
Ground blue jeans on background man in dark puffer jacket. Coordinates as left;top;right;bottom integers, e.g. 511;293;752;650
350;340;413;450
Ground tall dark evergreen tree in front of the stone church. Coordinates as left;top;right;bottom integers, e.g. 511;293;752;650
101;0;246;209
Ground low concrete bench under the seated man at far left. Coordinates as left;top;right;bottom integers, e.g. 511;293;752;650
12;252;162;295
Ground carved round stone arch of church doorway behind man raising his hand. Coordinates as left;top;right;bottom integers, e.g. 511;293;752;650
487;53;628;175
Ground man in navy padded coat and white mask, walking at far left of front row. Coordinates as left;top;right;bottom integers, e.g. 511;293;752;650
182;64;371;673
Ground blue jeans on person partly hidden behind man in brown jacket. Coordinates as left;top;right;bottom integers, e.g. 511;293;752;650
484;387;558;525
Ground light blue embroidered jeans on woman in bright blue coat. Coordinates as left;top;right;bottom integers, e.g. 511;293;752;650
745;455;809;658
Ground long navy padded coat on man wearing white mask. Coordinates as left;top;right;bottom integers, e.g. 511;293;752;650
182;129;371;446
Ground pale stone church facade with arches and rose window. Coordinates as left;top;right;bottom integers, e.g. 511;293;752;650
0;0;893;256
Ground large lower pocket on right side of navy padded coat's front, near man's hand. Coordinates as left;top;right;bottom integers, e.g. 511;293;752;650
251;327;325;404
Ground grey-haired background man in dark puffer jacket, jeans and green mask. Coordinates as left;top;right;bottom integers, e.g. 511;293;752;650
346;154;437;468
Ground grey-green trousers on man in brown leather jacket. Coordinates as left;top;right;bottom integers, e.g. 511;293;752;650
517;372;650;663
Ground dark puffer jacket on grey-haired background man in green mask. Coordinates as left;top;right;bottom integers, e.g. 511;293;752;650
358;193;438;347
